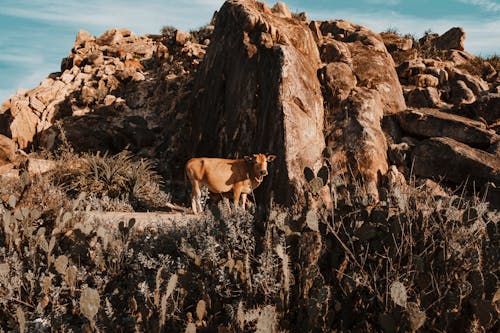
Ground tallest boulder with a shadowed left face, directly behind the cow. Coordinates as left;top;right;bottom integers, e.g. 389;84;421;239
190;0;325;204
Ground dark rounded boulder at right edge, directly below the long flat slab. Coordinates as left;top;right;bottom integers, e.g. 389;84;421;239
412;137;500;188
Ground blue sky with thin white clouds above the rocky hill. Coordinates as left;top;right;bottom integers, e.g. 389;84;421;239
0;0;500;103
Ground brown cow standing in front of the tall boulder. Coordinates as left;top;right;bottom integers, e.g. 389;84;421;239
186;154;276;214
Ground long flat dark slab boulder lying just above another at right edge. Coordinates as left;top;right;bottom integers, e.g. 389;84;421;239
397;109;498;148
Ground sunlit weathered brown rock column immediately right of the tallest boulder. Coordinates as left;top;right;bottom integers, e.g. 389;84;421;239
318;20;406;202
